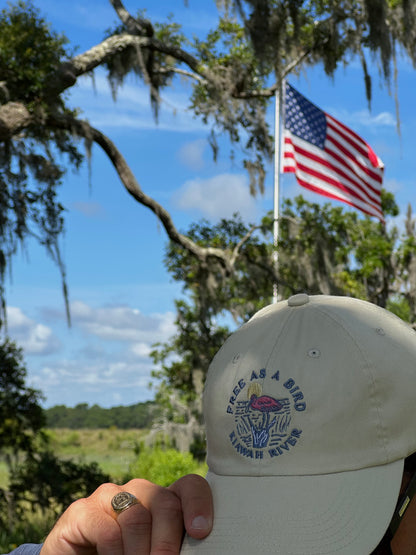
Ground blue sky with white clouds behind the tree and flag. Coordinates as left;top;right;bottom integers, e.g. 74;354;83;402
0;0;416;408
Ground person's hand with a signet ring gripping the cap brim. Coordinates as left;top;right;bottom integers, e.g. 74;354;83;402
41;474;212;555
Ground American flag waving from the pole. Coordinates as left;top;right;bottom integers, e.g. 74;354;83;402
282;83;384;222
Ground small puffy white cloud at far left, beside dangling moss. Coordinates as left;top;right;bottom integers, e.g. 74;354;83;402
7;306;60;355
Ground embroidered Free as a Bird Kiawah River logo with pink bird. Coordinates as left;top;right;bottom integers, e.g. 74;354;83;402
227;368;306;459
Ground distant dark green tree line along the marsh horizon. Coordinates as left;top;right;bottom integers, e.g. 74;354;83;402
45;401;159;430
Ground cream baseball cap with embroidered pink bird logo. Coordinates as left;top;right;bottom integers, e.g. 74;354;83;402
182;294;416;555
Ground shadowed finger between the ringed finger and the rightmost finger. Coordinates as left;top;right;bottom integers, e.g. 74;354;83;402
126;479;184;555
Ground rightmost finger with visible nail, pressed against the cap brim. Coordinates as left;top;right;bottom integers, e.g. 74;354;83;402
169;474;214;539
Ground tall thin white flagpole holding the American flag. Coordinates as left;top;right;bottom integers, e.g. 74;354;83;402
273;83;283;303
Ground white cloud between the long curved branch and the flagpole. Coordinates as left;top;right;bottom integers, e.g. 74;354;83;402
173;173;258;224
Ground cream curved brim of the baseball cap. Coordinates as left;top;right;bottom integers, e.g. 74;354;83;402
182;460;403;555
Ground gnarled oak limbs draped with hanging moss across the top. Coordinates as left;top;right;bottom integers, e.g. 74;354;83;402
0;0;416;326
